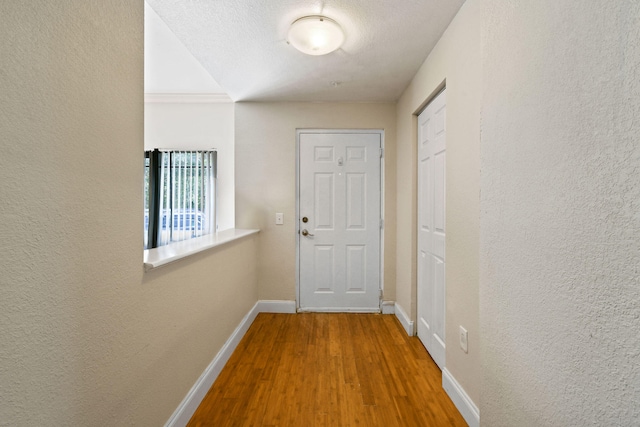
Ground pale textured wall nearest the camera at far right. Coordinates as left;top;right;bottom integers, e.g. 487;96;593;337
480;0;640;426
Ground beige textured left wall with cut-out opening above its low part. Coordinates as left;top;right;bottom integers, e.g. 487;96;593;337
0;0;259;426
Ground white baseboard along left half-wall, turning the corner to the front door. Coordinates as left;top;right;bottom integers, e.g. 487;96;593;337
165;301;296;427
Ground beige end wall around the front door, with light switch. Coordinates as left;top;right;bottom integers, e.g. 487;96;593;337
235;102;396;300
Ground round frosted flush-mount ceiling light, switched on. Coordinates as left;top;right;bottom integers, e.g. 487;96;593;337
287;15;344;55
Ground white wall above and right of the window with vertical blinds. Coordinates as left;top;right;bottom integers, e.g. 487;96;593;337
144;100;235;230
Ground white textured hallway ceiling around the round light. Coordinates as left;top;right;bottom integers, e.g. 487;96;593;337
147;0;464;102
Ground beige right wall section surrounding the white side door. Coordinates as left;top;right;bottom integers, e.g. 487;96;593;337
396;0;481;405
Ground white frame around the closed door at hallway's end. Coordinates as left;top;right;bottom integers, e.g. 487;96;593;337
295;128;386;313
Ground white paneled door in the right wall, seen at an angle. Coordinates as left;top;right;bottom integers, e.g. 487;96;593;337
418;90;446;369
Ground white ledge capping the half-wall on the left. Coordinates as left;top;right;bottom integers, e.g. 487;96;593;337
144;228;260;271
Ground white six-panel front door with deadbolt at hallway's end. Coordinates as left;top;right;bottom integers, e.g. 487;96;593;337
298;130;382;312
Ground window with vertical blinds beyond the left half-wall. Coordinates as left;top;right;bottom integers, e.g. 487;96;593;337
144;149;217;249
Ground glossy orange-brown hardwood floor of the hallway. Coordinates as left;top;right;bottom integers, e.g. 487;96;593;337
188;313;467;427
